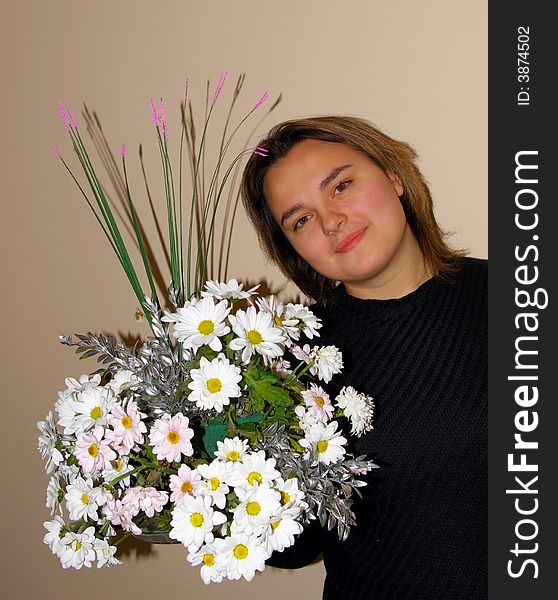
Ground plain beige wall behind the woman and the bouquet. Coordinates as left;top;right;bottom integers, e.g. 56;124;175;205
0;0;487;600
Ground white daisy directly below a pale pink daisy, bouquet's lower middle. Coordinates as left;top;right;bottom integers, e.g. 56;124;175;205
169;496;227;552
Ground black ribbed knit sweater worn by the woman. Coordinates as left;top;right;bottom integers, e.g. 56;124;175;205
269;258;488;600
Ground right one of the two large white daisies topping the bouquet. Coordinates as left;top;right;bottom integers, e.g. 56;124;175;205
229;306;286;363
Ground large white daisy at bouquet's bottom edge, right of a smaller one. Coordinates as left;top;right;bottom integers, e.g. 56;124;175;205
215;533;270;581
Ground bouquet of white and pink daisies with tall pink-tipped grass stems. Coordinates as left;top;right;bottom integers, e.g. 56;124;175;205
38;77;376;583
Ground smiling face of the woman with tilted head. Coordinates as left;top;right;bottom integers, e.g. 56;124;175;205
264;140;420;297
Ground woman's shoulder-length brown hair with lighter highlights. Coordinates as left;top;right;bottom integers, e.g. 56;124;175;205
241;116;465;300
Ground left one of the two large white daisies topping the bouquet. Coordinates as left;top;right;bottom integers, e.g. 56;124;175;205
161;297;230;352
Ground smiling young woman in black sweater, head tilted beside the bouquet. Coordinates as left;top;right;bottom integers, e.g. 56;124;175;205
242;116;487;600
